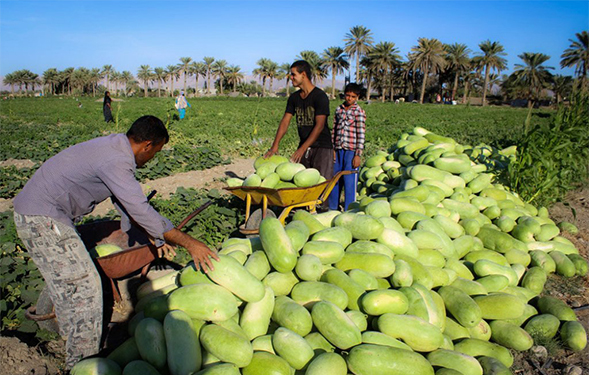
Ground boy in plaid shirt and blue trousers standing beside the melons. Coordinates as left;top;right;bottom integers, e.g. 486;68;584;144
329;83;366;210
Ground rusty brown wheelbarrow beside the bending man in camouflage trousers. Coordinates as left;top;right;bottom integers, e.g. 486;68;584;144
25;201;212;332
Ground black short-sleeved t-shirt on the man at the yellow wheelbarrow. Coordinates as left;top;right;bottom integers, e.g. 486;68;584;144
286;87;333;148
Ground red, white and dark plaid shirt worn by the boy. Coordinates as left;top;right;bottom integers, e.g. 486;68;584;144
331;104;366;154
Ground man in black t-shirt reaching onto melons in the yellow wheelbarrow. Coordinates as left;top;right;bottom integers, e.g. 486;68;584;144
264;60;333;180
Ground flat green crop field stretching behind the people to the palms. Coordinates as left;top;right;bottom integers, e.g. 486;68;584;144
0;98;554;161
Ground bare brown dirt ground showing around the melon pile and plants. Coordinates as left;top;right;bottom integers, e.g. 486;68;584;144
0;159;589;375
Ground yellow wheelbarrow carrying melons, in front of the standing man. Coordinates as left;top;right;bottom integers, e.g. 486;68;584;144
225;171;357;235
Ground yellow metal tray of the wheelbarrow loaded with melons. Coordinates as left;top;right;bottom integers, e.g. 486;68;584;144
225;181;330;207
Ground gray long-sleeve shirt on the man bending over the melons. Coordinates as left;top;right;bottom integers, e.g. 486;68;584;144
13;134;174;246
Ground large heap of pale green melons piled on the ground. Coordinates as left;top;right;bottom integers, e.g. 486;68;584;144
72;128;588;375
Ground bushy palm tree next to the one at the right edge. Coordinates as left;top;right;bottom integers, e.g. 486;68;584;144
512;52;554;108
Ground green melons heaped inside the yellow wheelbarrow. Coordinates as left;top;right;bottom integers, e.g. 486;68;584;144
227;155;325;189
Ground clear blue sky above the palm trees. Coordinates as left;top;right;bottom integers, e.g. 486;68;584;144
0;0;589;75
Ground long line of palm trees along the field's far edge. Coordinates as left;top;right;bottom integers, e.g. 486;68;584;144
4;26;589;106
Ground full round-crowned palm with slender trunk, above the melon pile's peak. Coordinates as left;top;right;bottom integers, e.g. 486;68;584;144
409;38;446;104
